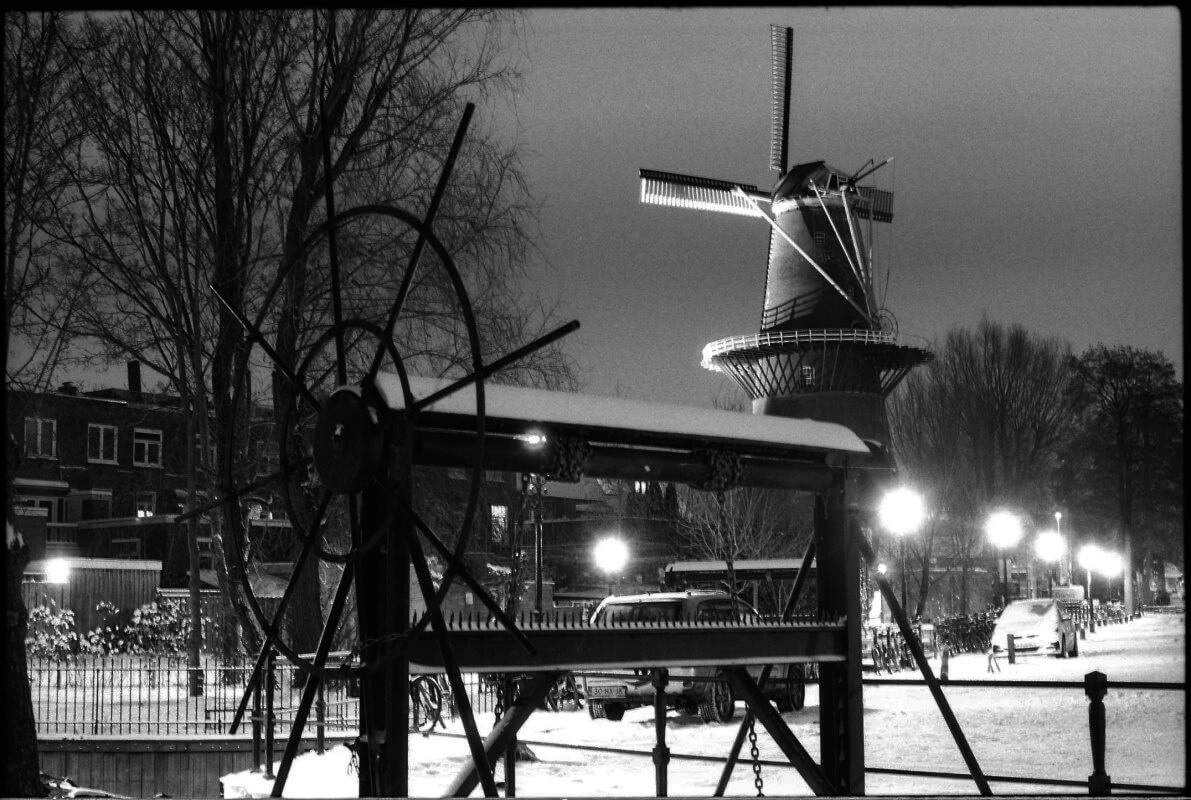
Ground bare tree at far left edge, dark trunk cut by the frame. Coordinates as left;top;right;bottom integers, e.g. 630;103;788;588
4;12;92;798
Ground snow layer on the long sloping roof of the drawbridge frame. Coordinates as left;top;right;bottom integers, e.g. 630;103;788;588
376;373;869;455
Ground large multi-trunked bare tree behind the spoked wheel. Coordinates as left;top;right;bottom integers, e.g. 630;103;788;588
54;8;570;650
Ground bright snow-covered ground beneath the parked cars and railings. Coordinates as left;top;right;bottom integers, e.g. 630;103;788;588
222;614;1186;798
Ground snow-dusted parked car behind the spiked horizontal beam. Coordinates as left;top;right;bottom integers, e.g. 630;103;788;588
578;590;806;723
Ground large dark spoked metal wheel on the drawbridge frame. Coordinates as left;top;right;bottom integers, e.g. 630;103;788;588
224;200;485;677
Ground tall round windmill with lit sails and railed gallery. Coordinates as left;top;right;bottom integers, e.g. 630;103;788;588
641;25;934;449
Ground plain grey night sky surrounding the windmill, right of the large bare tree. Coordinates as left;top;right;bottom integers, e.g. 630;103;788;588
500;7;1183;406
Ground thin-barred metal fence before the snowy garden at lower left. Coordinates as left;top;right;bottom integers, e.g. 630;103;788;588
29;656;494;736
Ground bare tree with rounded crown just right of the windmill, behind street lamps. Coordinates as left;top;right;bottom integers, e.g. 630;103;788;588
888;319;1073;614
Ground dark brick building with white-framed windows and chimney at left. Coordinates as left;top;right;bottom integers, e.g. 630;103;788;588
7;362;215;587
